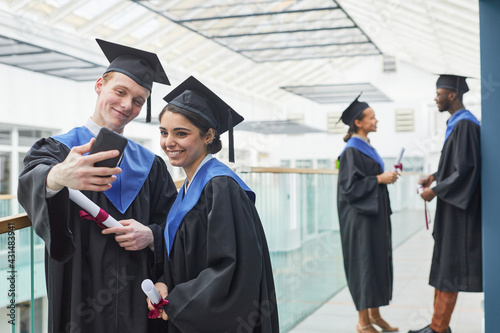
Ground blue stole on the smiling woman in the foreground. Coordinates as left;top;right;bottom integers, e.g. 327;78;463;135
165;158;255;258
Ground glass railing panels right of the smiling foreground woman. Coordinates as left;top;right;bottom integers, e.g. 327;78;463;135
240;169;425;332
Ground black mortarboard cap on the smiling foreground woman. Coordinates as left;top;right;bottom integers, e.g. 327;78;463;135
163;76;243;162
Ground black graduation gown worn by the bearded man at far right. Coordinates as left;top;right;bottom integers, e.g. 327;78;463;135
429;120;483;292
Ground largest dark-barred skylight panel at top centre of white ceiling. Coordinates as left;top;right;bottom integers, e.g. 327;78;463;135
136;0;381;63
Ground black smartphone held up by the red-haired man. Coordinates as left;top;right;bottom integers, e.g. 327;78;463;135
89;127;128;168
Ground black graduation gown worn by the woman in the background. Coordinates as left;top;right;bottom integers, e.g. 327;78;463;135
337;148;393;311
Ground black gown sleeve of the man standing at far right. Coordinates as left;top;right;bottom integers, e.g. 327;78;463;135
433;120;481;209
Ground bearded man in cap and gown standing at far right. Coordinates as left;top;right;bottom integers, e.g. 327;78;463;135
409;75;483;333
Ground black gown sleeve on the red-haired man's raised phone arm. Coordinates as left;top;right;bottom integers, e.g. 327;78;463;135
17;138;75;263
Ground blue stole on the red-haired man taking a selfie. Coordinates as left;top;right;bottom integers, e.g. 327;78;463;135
52;126;155;214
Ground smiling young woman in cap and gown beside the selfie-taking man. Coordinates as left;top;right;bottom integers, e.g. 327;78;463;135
148;76;279;333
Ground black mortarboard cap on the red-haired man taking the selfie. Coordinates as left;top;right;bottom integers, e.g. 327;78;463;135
96;38;170;123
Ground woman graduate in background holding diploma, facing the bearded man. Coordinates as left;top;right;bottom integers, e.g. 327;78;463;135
337;92;398;333
